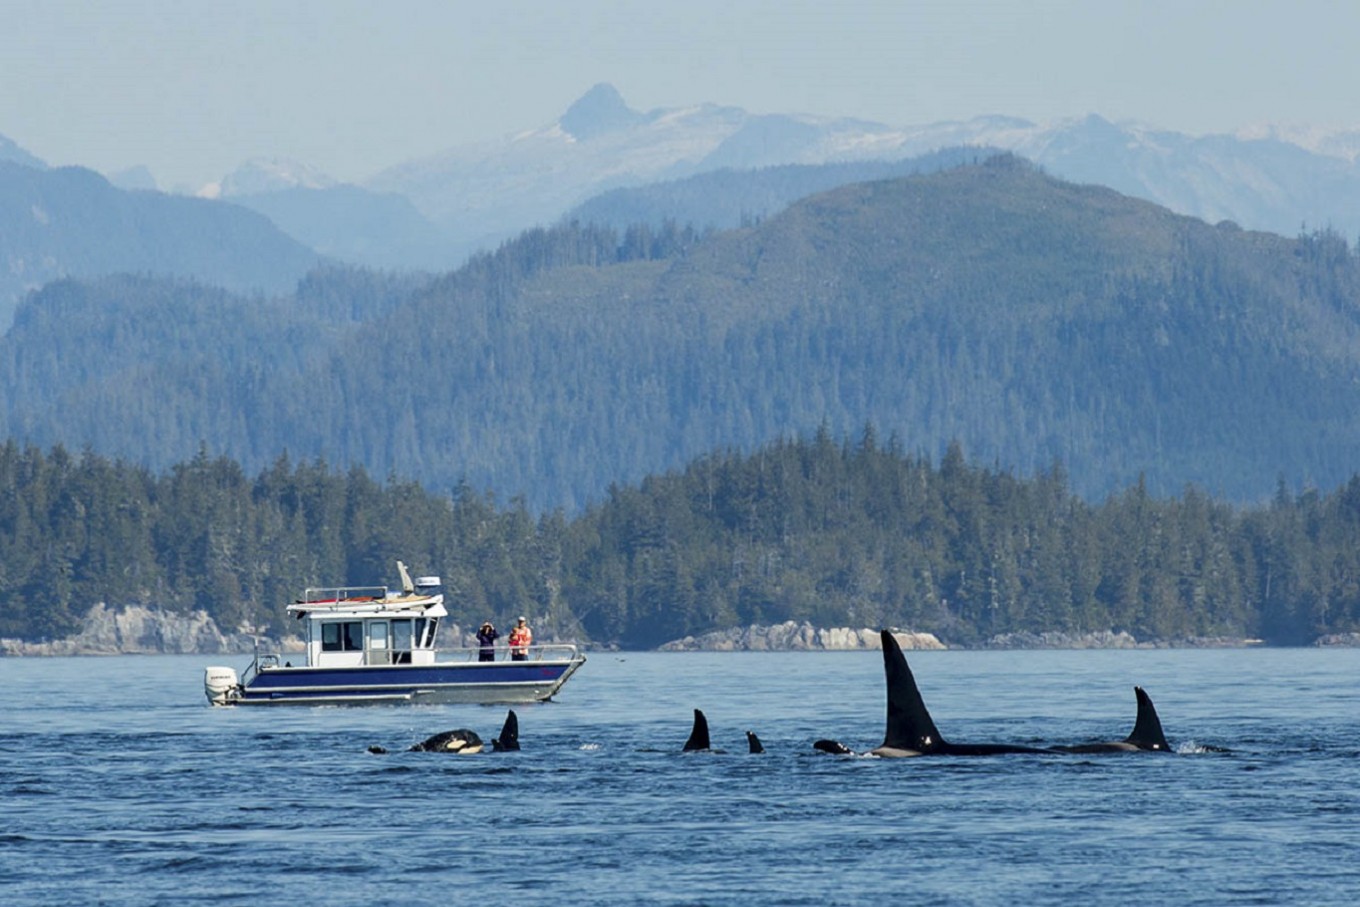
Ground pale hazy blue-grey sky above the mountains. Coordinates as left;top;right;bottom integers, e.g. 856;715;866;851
0;0;1360;186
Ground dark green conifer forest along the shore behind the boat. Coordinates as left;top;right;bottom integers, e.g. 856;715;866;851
0;427;1360;647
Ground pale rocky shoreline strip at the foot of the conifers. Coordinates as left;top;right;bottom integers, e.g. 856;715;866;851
0;604;1360;657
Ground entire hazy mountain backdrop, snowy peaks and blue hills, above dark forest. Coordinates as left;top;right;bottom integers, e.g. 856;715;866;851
0;86;1360;510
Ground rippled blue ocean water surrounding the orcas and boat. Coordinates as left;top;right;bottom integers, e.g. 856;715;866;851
0;649;1360;906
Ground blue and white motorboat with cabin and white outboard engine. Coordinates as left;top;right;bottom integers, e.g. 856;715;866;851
203;560;586;706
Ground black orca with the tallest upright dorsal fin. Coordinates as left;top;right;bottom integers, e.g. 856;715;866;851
813;630;1058;759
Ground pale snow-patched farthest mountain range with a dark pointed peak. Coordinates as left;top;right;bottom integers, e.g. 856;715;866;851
364;84;1360;262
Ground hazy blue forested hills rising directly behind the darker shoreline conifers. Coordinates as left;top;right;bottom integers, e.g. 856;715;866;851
0;158;1360;513
